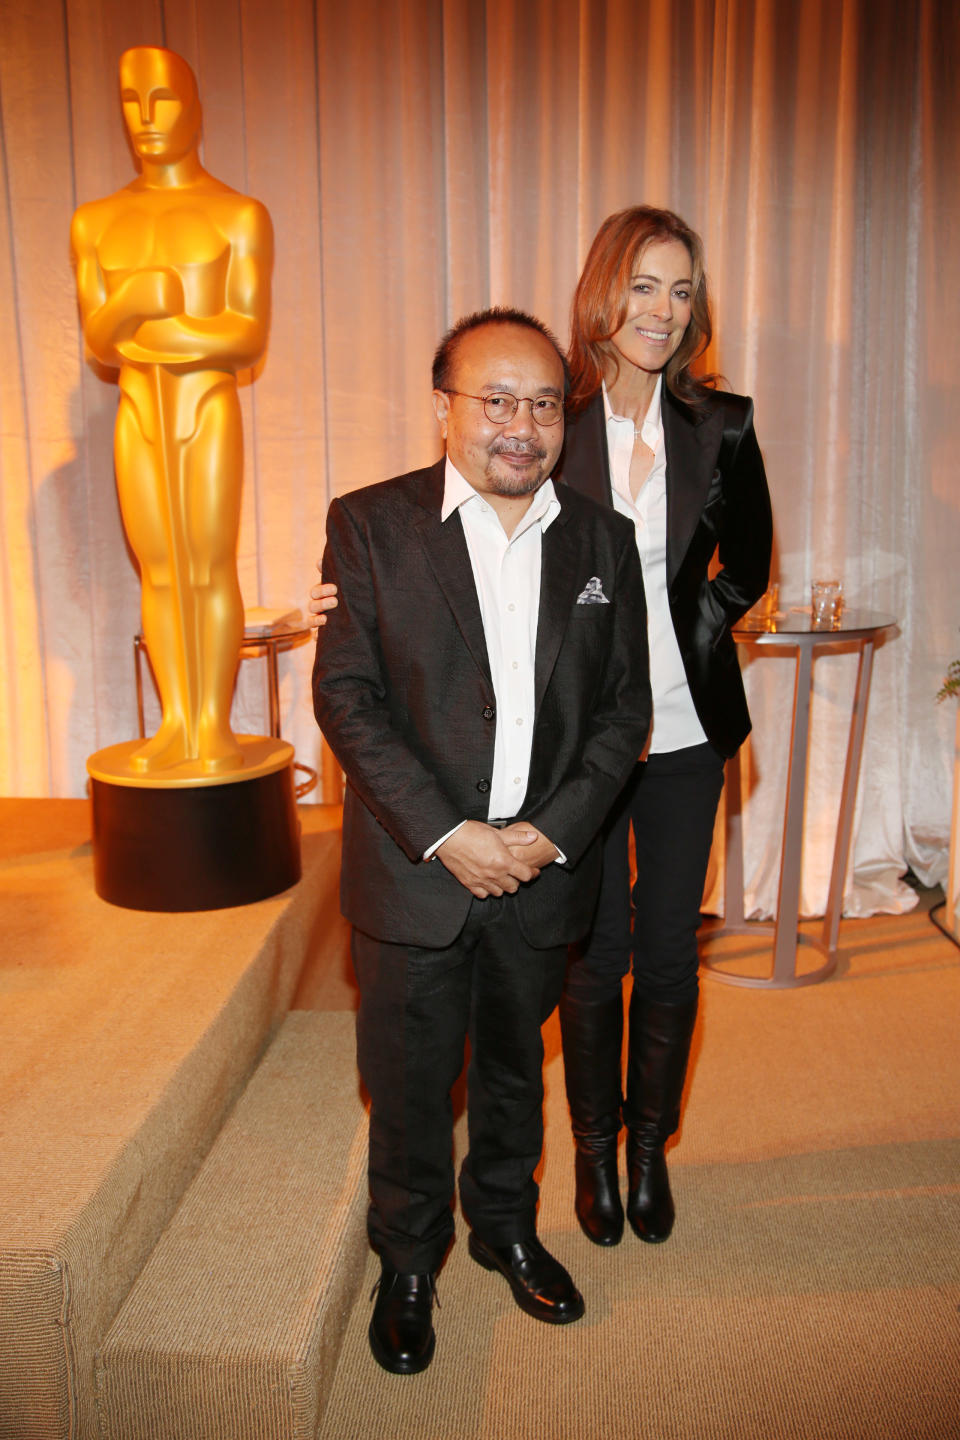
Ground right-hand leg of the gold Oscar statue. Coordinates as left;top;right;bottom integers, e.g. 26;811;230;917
183;386;243;772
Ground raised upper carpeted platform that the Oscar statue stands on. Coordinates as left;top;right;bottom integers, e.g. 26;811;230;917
0;801;349;1440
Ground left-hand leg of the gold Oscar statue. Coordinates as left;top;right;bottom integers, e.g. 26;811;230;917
114;393;193;772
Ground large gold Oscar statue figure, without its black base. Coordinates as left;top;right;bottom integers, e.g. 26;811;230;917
71;46;273;785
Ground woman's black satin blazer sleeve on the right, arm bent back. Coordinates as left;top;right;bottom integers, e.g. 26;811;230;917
710;400;773;626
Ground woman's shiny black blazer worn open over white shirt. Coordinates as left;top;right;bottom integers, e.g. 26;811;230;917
557;384;773;757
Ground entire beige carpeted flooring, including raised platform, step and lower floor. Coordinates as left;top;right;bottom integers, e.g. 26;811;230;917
0;802;960;1440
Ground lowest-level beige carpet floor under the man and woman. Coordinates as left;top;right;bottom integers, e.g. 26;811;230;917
320;912;960;1440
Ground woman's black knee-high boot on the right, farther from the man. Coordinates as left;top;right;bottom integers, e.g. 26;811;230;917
623;985;697;1244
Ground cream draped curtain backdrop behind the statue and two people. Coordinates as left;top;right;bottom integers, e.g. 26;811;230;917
0;0;960;913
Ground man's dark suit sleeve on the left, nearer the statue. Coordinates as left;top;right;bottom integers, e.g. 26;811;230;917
314;500;463;861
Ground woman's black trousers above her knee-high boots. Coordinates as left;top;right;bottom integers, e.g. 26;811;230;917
567;744;724;1005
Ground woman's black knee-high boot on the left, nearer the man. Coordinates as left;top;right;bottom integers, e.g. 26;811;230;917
560;989;623;1246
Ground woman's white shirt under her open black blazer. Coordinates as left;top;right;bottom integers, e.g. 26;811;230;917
603;376;707;753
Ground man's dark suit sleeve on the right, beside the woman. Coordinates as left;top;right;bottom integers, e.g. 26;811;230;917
520;527;653;865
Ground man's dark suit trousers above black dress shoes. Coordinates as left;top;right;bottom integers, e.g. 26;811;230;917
353;892;566;1274
